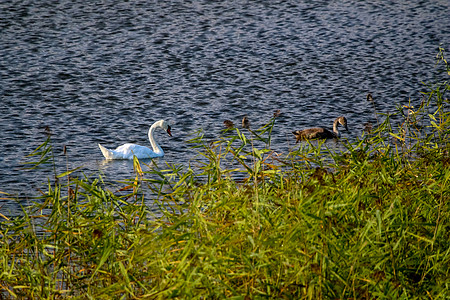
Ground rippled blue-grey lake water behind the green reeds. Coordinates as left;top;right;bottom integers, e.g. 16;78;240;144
0;0;450;211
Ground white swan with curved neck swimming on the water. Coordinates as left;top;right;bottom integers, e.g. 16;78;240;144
98;120;172;159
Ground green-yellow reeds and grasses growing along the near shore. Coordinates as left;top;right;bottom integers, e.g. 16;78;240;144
0;48;450;299
